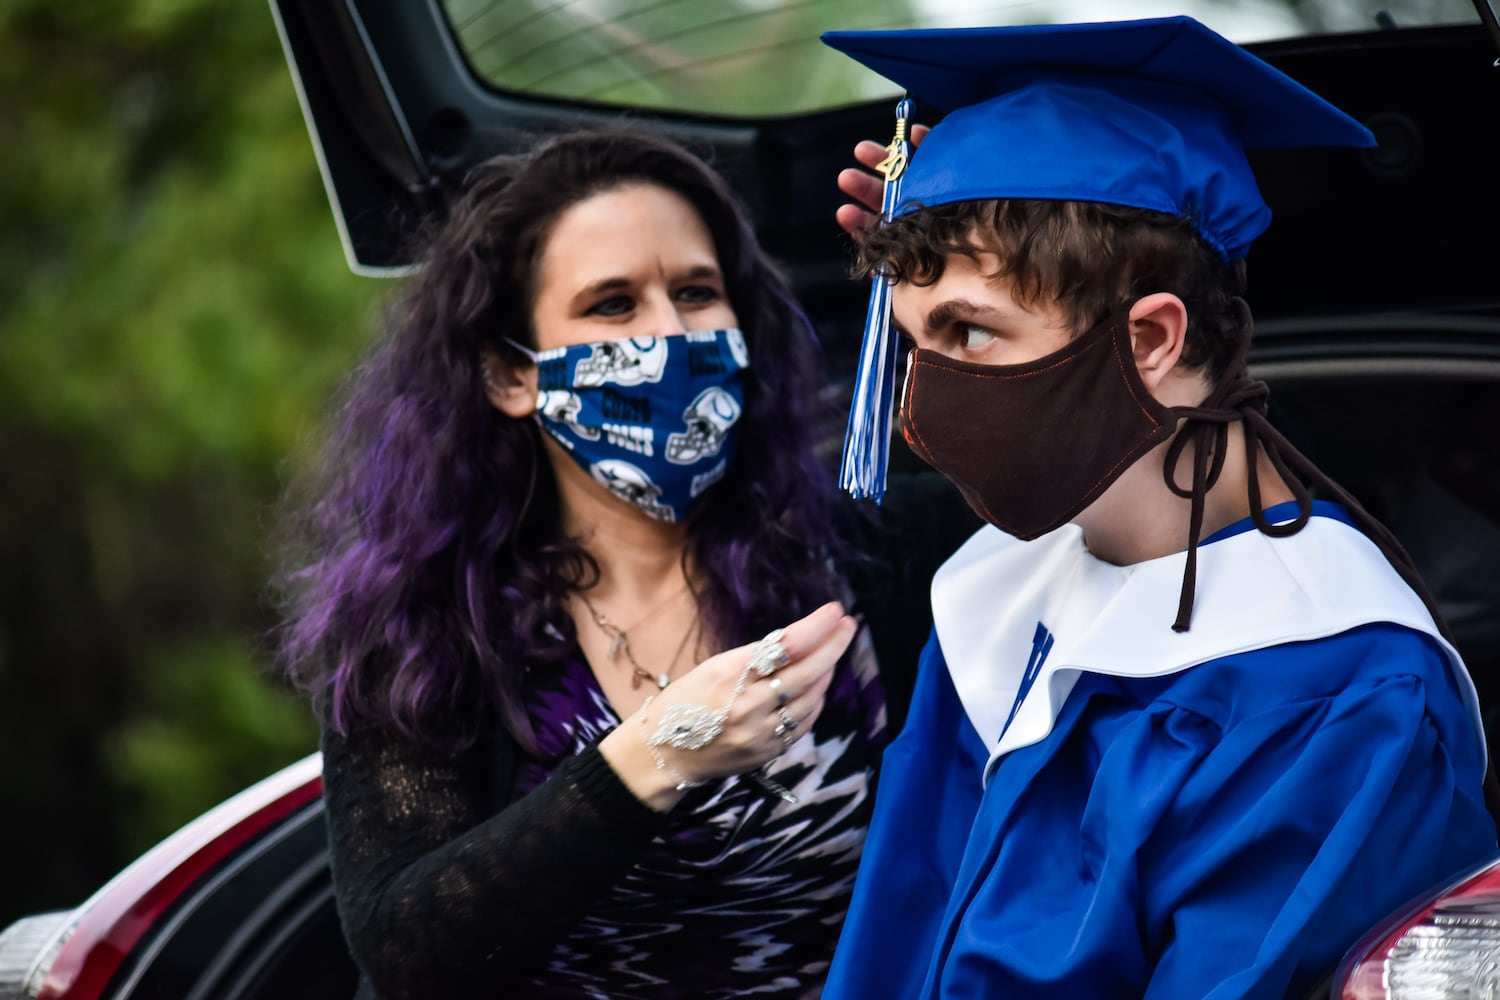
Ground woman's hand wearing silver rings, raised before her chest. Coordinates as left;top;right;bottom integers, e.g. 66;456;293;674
599;601;858;810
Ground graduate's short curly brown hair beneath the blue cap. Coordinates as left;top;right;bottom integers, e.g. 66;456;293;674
857;198;1245;382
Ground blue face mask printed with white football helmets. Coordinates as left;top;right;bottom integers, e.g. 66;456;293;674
515;330;750;520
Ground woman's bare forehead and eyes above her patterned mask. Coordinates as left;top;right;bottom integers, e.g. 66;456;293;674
531;181;740;351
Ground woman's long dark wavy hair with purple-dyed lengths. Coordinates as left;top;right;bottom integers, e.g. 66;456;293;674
278;129;843;745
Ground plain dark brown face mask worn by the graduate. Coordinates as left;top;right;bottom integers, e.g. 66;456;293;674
902;309;1176;538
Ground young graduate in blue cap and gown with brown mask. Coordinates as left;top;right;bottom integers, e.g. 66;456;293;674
824;18;1496;999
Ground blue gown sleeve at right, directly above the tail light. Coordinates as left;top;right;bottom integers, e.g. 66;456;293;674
1134;628;1496;1000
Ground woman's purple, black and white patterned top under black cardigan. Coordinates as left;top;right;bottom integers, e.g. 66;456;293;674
516;633;885;1000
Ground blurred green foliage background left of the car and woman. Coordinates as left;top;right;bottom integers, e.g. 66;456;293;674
0;0;381;927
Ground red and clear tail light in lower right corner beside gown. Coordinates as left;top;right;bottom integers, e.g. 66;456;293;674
1334;861;1500;1000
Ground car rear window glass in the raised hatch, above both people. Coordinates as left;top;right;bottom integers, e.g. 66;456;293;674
443;0;1478;117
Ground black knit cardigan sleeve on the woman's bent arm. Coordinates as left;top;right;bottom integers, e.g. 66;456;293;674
323;716;666;1000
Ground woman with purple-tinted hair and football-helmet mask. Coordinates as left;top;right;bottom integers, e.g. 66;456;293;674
274;132;900;999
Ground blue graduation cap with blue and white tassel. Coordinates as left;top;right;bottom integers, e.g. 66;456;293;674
822;16;1376;498
